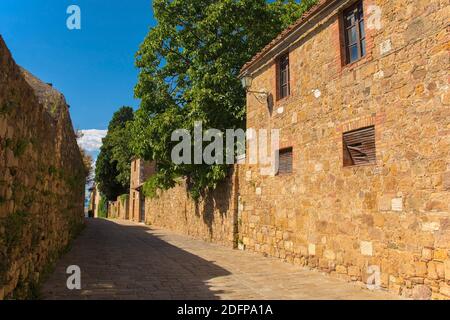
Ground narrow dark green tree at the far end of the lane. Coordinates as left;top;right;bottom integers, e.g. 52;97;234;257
95;107;134;201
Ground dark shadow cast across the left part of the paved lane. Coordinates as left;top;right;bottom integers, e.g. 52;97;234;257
42;219;230;300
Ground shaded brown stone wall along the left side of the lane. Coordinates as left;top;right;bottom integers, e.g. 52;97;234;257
0;37;85;299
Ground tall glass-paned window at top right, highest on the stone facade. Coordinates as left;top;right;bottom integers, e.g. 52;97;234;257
343;1;366;63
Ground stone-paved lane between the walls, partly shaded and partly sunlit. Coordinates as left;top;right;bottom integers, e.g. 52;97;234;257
42;219;394;299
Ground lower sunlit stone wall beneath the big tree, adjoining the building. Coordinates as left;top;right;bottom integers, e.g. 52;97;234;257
145;168;238;247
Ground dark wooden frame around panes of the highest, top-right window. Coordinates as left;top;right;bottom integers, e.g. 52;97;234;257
341;0;367;65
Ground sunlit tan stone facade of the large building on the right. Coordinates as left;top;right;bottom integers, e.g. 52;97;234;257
239;0;450;299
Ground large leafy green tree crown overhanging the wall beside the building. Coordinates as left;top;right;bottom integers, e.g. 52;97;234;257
130;0;314;197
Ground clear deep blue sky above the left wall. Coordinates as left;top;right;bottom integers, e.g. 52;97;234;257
0;0;155;134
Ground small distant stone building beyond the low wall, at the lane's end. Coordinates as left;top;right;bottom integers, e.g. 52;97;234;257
129;159;156;222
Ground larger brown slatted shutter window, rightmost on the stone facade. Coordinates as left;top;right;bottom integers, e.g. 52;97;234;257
343;126;376;167
